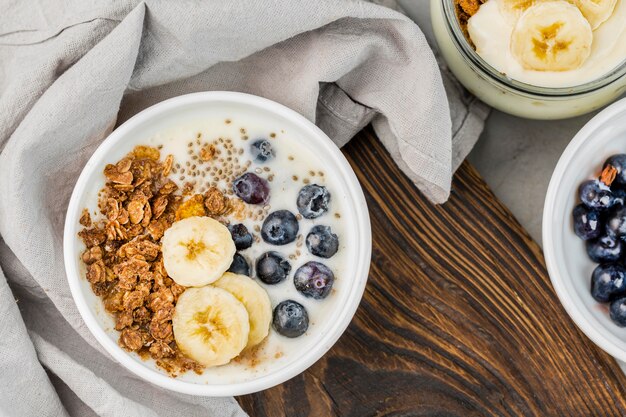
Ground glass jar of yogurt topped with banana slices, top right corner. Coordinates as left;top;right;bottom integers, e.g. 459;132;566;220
430;0;626;119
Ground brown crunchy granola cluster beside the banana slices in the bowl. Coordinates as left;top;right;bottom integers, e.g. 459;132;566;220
79;146;240;376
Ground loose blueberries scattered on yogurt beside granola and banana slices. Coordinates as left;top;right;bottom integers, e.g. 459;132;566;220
229;139;339;337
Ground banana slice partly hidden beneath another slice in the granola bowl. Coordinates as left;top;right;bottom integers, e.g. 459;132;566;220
213;272;272;349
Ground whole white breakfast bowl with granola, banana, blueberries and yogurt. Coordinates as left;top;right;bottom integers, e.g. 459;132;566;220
63;92;371;396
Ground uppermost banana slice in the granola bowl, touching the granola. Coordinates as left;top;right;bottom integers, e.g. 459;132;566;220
161;216;236;287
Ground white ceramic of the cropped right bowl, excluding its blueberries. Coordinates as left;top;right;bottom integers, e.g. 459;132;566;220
543;99;626;361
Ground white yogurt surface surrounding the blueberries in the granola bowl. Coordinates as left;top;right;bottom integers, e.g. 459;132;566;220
86;108;355;384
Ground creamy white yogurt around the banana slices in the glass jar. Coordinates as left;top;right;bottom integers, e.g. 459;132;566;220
467;0;626;88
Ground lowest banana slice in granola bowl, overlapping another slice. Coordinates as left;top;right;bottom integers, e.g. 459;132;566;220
172;286;250;367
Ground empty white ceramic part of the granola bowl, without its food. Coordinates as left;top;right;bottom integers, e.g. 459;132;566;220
63;92;371;396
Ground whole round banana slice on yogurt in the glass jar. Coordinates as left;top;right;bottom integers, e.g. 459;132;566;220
511;0;593;71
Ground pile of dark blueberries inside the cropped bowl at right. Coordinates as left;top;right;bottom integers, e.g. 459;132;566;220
573;154;626;327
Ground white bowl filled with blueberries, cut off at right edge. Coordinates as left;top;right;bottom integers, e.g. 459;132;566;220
543;99;626;361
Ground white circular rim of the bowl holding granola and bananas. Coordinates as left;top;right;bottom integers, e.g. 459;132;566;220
63;91;372;397
